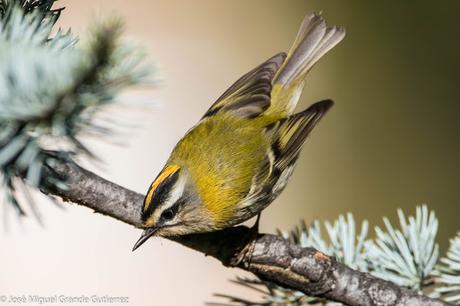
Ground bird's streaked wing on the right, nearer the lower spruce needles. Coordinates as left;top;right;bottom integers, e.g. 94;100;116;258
241;100;333;212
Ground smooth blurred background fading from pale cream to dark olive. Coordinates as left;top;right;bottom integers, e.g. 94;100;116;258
0;0;460;306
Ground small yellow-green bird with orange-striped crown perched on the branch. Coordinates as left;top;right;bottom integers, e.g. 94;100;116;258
133;14;345;251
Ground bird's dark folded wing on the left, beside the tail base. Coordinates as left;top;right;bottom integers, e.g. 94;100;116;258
202;53;286;119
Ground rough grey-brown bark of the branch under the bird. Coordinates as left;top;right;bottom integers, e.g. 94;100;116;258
41;163;450;306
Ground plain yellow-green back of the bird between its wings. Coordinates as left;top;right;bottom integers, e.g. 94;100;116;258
168;113;270;224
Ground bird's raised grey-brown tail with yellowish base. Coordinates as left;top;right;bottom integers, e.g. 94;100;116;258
272;14;345;115
